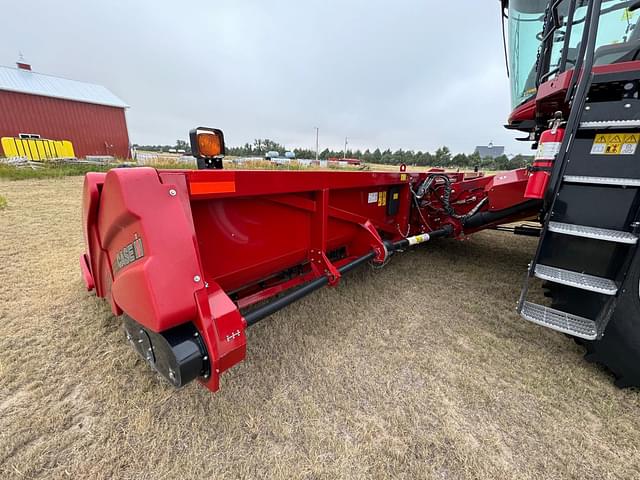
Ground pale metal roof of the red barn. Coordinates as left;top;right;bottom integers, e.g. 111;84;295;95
0;65;129;108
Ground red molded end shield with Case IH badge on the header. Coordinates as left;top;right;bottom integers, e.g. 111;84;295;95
98;168;204;332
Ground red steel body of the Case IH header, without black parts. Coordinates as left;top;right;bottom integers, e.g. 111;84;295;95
81;168;535;391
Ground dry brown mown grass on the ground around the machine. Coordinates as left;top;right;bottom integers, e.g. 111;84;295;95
0;177;640;480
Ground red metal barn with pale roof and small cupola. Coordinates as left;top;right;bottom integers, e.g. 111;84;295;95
0;62;129;158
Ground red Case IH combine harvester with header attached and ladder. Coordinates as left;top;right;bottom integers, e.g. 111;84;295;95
81;0;640;391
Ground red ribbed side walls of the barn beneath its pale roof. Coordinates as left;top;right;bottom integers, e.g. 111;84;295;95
0;91;129;158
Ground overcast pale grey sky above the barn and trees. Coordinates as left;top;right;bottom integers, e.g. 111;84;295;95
0;0;528;153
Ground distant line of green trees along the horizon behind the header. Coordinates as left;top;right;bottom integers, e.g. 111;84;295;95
134;138;533;170
